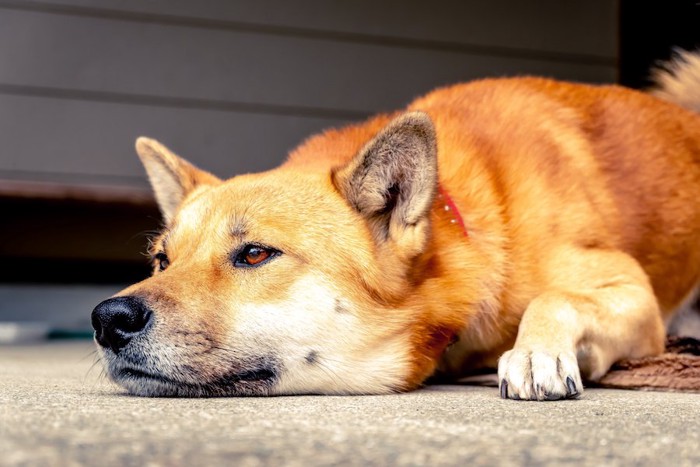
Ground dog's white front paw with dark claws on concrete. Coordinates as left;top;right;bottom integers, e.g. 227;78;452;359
498;348;583;401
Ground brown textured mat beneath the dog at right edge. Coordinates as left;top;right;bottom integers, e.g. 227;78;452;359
594;336;700;393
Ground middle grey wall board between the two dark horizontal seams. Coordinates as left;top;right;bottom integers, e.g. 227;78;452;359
0;10;615;117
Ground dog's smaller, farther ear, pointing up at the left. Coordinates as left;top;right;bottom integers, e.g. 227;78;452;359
131;136;221;224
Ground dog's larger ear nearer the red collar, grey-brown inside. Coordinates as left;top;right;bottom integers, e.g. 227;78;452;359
333;112;437;259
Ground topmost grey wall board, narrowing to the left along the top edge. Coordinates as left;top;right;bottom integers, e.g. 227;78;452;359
6;0;617;58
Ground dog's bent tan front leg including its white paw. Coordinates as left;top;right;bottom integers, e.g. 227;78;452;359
498;248;665;400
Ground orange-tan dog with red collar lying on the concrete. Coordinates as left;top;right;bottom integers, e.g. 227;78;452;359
92;52;700;400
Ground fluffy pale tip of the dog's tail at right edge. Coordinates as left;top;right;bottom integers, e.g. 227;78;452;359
651;50;700;113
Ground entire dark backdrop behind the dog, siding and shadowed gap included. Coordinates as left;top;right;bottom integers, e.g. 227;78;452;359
0;0;700;330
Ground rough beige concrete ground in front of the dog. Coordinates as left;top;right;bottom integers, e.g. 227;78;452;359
0;342;700;466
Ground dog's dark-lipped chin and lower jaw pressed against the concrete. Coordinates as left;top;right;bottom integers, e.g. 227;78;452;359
109;367;277;397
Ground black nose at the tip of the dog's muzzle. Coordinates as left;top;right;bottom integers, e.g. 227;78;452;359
92;297;153;353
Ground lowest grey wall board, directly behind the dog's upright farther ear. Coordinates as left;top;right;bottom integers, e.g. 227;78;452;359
0;95;343;186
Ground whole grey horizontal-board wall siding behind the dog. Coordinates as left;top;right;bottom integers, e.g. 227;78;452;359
0;0;616;187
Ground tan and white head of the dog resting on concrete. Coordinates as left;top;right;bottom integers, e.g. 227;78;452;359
92;112;460;396
